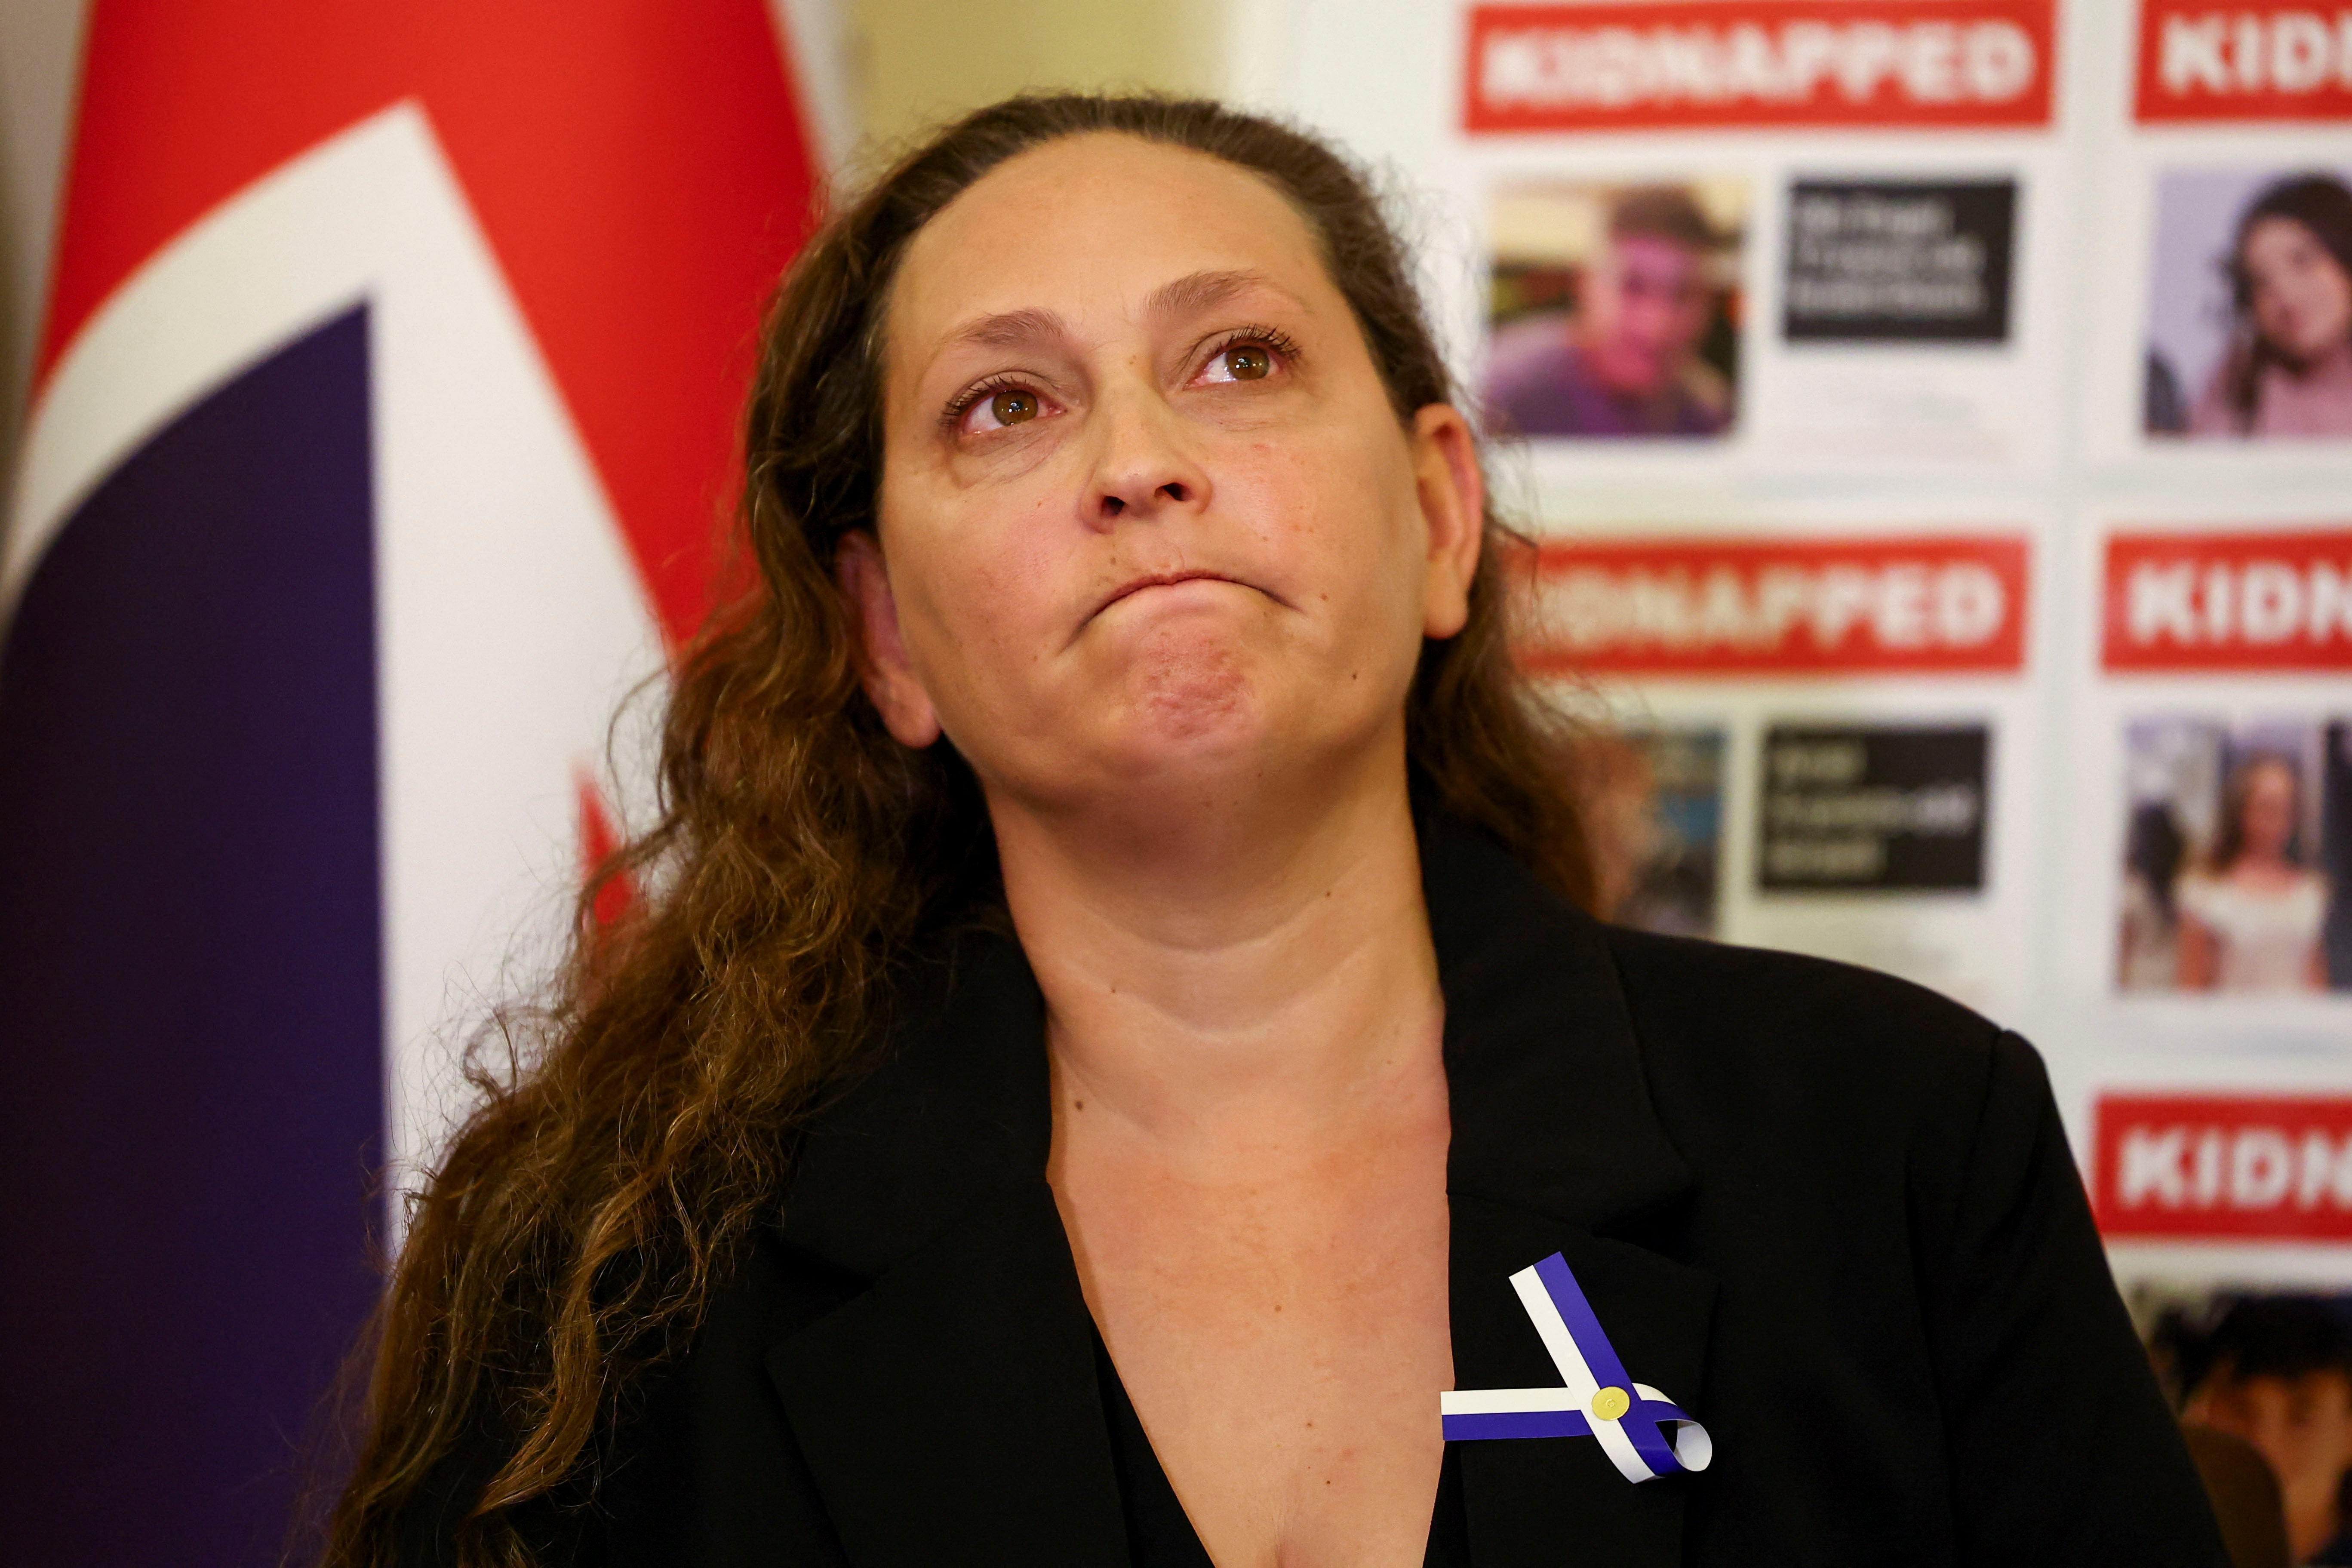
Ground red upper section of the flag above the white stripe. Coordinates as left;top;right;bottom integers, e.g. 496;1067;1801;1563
40;0;816;637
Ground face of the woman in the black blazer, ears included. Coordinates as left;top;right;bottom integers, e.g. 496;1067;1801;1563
842;134;1479;811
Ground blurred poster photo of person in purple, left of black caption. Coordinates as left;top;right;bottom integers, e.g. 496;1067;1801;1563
1486;181;1745;437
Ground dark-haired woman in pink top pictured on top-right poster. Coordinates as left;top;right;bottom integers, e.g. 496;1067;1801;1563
2190;174;2352;435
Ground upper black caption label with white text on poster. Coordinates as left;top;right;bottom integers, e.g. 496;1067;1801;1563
1780;178;2018;343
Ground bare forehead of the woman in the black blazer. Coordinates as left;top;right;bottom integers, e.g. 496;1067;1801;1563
889;132;1336;355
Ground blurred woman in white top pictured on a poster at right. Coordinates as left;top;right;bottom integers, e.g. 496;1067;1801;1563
2178;752;2328;992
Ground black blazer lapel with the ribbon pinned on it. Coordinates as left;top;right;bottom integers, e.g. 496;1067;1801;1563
1420;818;1715;1568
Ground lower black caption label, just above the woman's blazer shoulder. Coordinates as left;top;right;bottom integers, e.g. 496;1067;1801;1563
1757;724;1990;893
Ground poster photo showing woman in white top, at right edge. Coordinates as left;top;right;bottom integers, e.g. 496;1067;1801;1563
2117;717;2352;994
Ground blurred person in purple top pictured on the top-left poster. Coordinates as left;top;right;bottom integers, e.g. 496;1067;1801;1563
1486;186;1731;435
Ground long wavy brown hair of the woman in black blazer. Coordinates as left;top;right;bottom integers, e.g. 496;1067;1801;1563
327;96;1593;1566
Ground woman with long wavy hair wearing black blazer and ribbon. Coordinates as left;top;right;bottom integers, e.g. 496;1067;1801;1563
334;99;2220;1568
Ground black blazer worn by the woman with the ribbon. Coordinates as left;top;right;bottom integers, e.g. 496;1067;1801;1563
409;823;2227;1568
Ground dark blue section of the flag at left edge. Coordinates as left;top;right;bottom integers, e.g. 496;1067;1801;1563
0;308;383;1568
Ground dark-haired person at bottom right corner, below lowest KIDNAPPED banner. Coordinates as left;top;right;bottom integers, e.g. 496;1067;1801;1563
2183;1295;2352;1563
